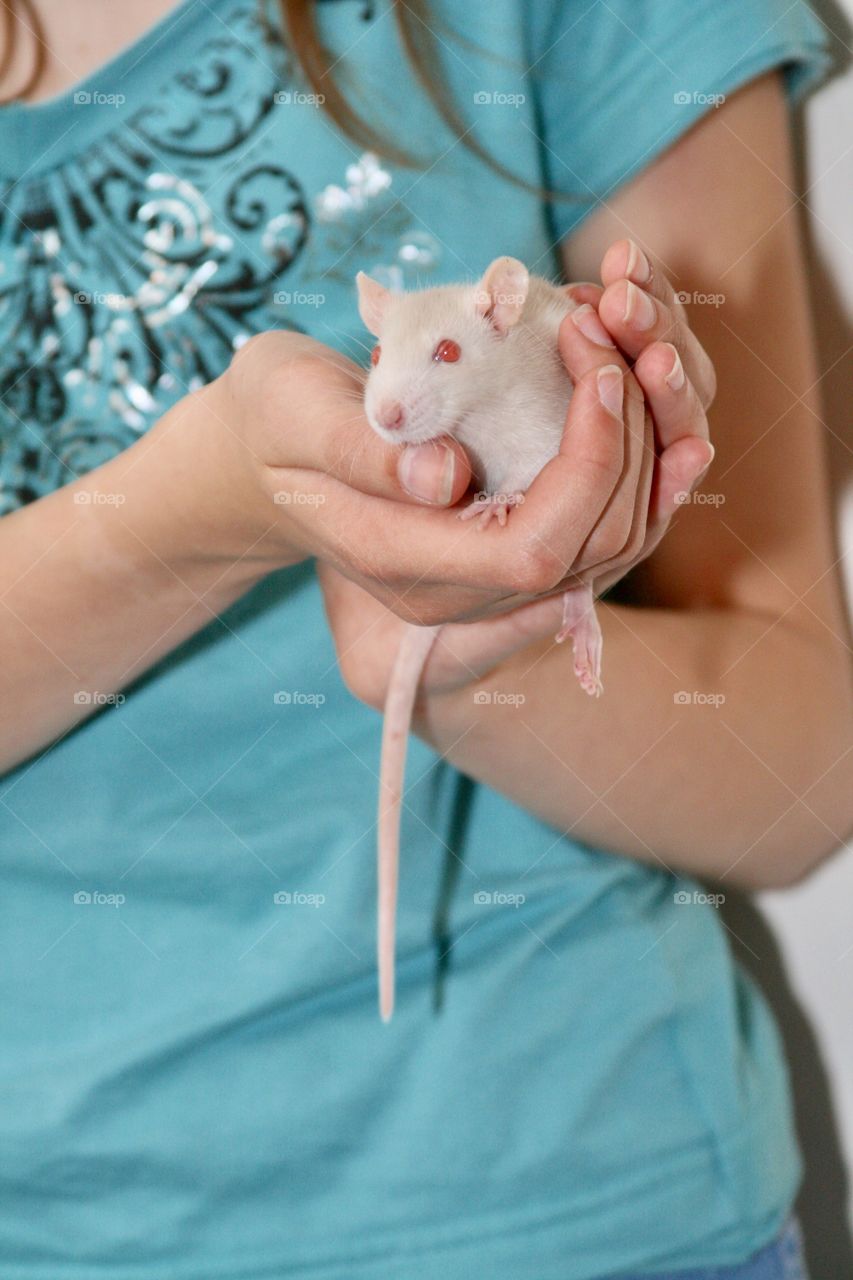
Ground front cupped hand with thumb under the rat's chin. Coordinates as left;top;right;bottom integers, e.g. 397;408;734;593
207;277;707;623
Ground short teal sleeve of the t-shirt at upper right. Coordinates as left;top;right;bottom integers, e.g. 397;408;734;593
526;0;831;239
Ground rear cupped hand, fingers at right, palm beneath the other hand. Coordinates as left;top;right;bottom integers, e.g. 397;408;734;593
312;241;716;708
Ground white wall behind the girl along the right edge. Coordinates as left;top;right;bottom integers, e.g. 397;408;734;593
734;0;853;1280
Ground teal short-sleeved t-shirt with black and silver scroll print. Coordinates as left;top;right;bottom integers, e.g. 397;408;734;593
0;0;826;1280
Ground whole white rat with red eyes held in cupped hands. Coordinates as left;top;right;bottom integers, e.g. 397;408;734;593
356;257;602;1021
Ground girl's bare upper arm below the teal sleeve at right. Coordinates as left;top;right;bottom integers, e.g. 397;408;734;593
564;73;844;634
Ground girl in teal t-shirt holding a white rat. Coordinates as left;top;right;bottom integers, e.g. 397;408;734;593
0;0;853;1280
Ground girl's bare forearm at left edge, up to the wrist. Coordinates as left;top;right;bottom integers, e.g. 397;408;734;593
0;389;275;772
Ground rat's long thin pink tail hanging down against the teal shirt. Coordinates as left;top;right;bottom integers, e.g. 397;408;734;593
377;627;441;1023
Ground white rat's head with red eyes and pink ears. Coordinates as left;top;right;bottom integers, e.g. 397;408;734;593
356;257;530;444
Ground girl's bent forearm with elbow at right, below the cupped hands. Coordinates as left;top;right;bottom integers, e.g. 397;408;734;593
418;605;853;887
